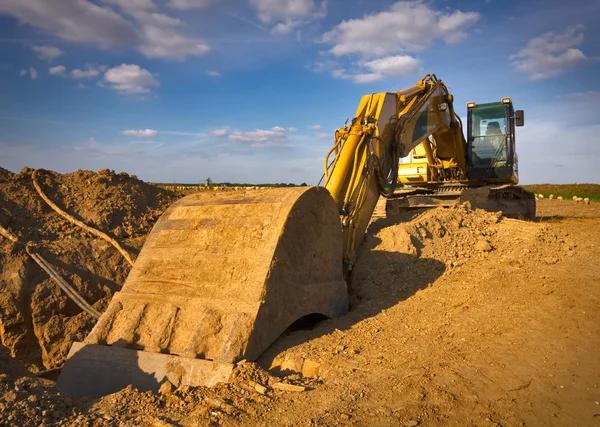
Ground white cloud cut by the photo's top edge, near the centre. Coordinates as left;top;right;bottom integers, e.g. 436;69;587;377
250;0;327;34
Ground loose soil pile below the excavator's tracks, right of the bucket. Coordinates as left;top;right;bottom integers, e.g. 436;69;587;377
350;203;575;314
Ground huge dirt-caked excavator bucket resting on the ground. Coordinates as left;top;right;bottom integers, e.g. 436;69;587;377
57;187;348;396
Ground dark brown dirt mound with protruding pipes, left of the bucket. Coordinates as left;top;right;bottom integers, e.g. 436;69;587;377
0;168;178;369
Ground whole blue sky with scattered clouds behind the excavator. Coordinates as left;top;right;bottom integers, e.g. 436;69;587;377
0;0;600;184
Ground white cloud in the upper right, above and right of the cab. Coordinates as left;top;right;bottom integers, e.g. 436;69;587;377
509;26;588;80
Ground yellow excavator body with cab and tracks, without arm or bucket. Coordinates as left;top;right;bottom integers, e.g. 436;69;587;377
390;88;536;219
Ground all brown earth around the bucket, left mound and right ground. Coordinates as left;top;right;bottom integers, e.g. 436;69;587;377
0;170;600;426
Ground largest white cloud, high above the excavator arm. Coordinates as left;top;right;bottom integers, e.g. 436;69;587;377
322;1;479;57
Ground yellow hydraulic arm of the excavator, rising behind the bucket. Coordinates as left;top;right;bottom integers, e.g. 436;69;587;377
325;74;467;271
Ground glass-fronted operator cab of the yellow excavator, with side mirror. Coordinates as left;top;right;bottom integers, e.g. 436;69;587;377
467;98;524;184
